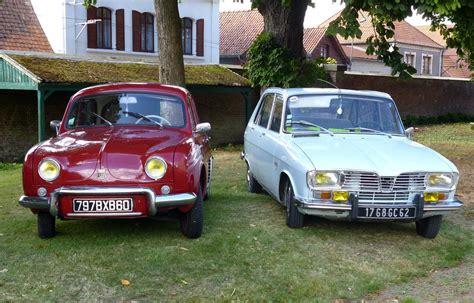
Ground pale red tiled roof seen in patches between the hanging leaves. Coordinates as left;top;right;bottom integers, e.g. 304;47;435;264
320;12;444;49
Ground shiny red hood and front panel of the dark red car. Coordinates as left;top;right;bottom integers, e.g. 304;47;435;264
34;127;185;184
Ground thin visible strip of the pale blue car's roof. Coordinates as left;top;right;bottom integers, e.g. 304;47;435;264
265;87;392;100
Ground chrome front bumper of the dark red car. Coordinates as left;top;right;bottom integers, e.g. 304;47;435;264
18;187;196;217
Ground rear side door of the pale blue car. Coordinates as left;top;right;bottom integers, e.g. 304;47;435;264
245;93;275;186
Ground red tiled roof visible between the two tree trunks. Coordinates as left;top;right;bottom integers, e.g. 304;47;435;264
220;10;263;56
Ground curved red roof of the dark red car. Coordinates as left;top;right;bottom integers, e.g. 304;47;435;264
72;82;189;99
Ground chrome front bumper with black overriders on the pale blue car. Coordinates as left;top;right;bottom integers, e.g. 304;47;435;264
296;194;463;220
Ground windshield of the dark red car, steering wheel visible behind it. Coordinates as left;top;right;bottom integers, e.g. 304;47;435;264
66;93;186;129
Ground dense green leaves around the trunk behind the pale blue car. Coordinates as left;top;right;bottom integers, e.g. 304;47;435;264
246;32;326;87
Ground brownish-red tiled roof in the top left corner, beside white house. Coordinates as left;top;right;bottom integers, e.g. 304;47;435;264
0;0;52;52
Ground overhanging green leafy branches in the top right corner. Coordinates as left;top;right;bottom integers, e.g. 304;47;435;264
328;0;474;77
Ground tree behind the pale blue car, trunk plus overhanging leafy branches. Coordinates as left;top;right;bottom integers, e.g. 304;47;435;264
248;0;474;86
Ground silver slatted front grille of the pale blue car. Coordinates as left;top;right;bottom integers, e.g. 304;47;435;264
342;171;425;192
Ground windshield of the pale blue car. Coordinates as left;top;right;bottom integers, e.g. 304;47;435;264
285;95;403;135
